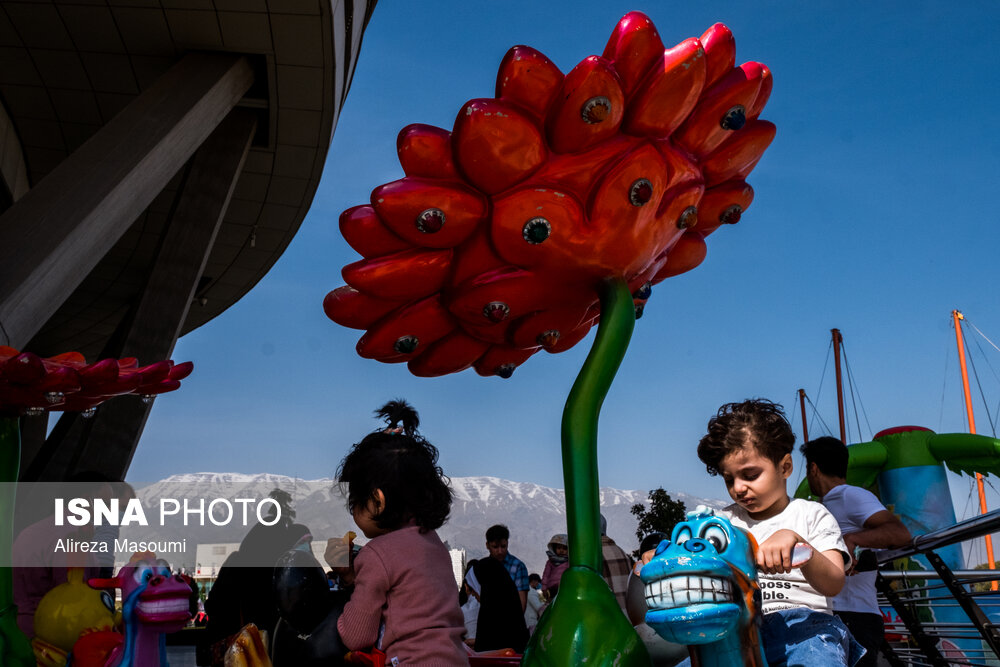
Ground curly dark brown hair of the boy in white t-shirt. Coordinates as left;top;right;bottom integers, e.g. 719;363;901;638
698;398;795;476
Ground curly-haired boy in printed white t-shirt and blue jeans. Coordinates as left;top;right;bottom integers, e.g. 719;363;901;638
698;398;864;667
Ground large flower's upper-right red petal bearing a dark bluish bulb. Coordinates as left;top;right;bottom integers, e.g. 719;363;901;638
674;63;764;157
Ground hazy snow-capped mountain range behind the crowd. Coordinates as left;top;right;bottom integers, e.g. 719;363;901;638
122;472;726;573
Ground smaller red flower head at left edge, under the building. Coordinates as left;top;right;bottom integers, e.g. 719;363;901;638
0;345;194;417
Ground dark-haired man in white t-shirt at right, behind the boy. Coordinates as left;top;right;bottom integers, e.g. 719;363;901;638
800;437;912;667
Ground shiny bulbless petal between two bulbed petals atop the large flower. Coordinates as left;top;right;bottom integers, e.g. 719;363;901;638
623;38;705;137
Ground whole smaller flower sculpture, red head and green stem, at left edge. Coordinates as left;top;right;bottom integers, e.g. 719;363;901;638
0;345;193;667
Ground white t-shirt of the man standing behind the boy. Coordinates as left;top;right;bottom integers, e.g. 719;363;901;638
823;484;885;614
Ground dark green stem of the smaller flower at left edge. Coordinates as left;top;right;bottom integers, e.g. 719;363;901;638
0;417;35;667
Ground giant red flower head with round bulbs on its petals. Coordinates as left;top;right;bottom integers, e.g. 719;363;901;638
324;12;775;377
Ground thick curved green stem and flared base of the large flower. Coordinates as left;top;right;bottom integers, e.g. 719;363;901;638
521;280;650;667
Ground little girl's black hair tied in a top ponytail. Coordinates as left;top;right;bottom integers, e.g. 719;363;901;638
337;400;451;532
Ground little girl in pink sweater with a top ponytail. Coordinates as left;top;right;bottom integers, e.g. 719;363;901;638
337;401;468;665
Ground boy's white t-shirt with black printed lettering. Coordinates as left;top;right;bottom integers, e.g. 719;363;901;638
723;498;847;614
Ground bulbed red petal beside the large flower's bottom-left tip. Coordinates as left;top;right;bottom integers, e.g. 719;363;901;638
358;296;455;361
